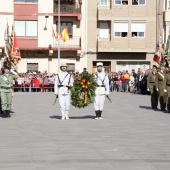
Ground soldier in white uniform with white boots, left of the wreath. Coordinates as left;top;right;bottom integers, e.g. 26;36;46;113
54;63;74;120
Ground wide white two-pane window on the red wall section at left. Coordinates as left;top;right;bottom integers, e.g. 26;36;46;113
15;21;37;37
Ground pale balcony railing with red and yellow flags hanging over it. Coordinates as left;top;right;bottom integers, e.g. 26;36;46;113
53;37;81;48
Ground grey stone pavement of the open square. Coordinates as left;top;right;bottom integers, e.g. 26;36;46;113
0;92;170;170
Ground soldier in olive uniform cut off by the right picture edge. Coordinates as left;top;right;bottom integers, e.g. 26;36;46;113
164;68;170;113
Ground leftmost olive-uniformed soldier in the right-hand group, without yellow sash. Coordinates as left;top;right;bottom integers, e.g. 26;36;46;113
147;65;158;111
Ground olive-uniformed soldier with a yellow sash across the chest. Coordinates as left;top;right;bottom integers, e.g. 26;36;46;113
156;64;166;111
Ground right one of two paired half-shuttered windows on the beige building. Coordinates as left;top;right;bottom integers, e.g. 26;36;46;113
131;23;146;38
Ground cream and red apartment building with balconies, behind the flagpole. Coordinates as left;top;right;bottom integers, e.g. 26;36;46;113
0;0;87;73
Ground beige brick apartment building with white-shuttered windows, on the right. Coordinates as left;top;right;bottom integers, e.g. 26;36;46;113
87;0;160;71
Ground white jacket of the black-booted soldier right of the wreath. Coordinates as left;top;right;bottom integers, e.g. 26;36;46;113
95;72;109;95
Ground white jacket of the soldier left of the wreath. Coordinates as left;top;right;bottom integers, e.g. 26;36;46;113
54;72;74;94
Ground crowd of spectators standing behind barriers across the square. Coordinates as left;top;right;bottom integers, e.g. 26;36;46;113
13;68;149;94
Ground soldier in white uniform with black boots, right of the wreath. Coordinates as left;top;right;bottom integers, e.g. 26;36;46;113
94;62;109;119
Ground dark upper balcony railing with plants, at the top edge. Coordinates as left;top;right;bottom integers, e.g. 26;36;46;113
54;3;81;13
